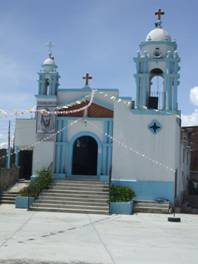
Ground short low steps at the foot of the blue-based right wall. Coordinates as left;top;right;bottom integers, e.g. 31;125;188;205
134;201;170;214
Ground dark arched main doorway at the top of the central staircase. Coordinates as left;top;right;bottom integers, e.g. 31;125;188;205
72;136;98;175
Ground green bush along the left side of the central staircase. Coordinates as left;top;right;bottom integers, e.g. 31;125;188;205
19;169;52;198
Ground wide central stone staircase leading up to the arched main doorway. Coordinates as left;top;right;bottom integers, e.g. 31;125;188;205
30;180;109;214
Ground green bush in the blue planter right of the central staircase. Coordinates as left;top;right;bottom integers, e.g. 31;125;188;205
110;185;135;202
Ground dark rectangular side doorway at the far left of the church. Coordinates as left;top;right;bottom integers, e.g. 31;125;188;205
19;150;33;180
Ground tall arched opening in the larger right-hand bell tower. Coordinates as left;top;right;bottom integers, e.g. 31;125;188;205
147;68;166;110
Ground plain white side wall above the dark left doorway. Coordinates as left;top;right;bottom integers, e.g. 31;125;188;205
15;119;36;148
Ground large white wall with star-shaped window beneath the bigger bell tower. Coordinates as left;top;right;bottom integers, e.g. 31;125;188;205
112;103;180;181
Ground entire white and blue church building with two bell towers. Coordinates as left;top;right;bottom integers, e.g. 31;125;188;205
15;10;184;202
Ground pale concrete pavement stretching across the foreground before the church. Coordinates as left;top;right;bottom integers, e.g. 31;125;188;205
0;205;198;264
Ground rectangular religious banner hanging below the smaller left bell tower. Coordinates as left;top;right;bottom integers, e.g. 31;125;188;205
37;107;55;134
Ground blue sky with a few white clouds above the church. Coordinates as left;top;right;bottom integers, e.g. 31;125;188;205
0;0;198;147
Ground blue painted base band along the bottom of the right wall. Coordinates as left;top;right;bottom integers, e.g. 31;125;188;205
112;179;174;203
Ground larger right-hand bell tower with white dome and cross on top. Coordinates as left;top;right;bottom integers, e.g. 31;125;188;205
134;9;180;112
